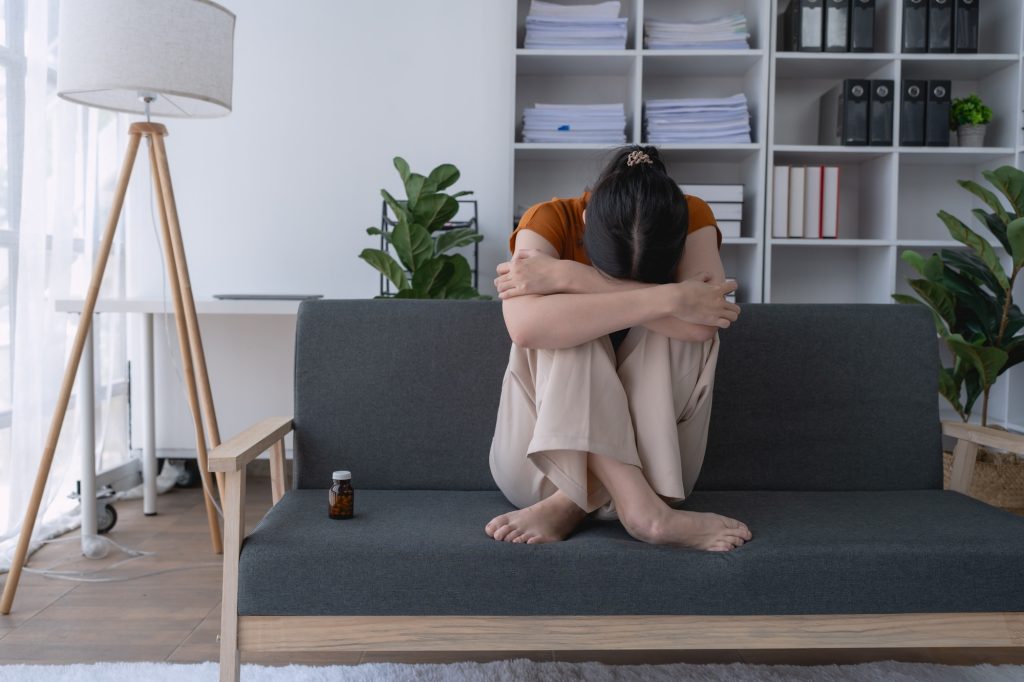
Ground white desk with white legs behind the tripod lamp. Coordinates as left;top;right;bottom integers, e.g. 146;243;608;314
56;298;299;538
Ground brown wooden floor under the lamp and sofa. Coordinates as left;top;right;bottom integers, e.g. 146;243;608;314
0;477;1024;665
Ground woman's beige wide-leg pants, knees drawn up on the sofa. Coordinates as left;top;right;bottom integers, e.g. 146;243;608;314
489;327;719;520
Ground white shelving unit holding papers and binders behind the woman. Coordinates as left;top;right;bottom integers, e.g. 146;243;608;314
510;0;1024;430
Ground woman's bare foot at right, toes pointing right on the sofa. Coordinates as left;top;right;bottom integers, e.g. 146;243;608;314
620;507;753;552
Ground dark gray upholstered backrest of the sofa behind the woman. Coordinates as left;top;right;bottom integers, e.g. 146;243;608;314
295;300;942;491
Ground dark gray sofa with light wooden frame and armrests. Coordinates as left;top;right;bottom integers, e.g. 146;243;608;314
210;300;1024;680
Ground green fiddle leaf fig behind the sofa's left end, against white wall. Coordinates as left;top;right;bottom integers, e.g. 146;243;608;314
359;157;489;299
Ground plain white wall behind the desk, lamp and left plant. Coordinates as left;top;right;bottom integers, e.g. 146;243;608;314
128;0;515;447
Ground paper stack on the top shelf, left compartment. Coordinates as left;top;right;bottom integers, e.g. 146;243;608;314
523;0;629;50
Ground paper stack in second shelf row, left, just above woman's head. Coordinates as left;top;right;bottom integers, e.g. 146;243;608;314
522;103;626;144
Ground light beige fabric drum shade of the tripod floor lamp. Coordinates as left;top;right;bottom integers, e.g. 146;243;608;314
57;0;234;118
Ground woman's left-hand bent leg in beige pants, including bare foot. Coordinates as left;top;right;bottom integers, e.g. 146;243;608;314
485;337;639;543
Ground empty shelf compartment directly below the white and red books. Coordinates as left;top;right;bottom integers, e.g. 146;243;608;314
769;245;894;303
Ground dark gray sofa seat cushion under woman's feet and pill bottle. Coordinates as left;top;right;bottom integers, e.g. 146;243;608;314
239;489;1024;615
